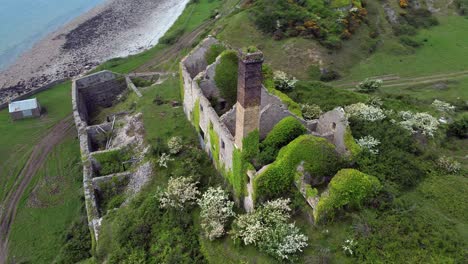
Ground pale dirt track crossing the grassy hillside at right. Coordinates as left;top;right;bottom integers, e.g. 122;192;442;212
335;71;468;89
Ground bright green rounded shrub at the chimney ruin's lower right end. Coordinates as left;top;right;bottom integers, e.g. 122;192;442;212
314;169;382;221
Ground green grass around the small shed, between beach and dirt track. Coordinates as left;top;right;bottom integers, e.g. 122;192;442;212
0;82;72;201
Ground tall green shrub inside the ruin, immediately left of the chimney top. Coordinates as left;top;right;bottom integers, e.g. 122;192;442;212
214;50;238;106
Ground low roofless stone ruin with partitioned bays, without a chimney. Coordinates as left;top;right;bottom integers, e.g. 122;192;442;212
72;71;152;241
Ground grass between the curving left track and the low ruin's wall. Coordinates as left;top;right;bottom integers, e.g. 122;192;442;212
9;135;83;263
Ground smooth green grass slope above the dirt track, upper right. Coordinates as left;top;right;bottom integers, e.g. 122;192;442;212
334;16;468;82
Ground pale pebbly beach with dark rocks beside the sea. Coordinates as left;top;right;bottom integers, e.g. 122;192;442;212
0;0;189;105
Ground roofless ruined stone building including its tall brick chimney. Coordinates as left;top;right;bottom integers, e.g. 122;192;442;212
180;37;347;209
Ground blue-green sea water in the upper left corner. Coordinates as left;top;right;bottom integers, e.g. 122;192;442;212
0;0;105;70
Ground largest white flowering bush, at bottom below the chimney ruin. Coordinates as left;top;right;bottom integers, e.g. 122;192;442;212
231;199;308;259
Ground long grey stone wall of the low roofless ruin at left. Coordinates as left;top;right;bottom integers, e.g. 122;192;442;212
72;71;145;243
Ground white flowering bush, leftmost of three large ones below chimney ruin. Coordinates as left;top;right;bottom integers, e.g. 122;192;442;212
159;177;200;209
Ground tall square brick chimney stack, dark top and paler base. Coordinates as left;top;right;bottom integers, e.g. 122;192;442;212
235;49;263;149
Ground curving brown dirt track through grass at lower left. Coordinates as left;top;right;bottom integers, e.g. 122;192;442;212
0;116;74;264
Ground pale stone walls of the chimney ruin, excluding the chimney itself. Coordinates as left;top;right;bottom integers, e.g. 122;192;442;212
180;37;347;208
